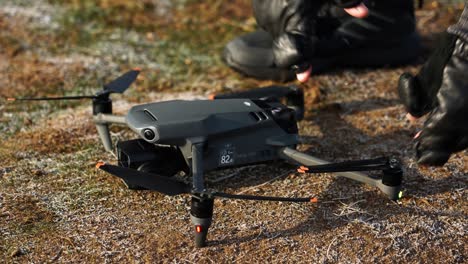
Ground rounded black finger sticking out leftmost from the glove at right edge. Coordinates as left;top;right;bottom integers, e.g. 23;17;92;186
398;73;431;117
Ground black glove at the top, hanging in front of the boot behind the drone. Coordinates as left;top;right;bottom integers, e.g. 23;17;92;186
252;0;362;72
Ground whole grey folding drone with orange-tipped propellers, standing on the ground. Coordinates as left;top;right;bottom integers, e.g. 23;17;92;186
8;69;403;247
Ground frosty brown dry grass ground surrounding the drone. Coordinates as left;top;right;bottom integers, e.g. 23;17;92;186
0;0;468;263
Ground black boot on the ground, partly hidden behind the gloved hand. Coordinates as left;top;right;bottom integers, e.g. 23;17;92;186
223;0;420;81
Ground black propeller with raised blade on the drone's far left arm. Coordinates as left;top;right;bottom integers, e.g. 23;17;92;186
7;68;141;101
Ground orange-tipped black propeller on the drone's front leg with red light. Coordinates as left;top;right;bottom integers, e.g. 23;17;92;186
96;162;317;203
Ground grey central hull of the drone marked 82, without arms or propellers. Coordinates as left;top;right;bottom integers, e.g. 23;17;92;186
126;99;299;171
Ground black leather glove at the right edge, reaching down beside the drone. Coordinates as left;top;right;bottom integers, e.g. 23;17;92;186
398;33;468;166
